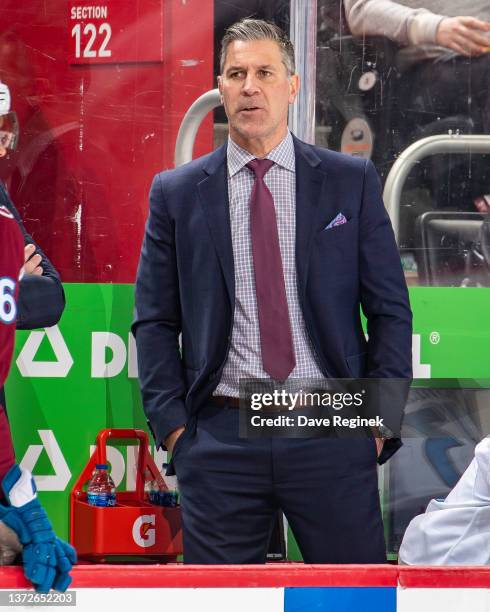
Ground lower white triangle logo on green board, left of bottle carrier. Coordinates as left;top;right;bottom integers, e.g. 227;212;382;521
20;429;71;491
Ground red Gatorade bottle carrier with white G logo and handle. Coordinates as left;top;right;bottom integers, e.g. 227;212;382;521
70;429;182;561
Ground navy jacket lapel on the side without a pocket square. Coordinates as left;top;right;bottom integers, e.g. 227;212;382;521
197;144;235;305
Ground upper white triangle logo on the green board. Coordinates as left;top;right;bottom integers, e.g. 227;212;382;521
16;325;73;378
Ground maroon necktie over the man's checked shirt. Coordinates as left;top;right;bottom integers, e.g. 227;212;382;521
247;159;296;380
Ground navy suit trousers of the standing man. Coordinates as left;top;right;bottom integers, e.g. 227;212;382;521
172;403;386;564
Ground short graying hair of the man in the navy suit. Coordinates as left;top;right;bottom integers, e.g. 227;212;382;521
219;17;295;76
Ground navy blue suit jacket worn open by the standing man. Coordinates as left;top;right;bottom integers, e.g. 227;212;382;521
132;138;412;460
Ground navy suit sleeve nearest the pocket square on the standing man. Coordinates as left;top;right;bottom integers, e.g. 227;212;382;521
360;162;412;463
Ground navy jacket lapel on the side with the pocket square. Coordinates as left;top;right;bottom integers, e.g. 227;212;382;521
293;136;326;297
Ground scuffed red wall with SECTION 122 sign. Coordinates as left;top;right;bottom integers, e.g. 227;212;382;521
0;0;213;283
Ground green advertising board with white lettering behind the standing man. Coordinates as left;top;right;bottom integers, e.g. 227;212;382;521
6;284;490;538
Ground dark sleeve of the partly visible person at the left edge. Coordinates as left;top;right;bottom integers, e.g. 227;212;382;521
0;183;65;329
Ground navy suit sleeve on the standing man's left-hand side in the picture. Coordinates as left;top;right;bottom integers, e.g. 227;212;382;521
132;175;187;446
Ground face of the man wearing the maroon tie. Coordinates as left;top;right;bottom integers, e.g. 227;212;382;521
218;40;299;156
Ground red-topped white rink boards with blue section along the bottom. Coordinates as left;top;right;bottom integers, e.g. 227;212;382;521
0;563;490;612
